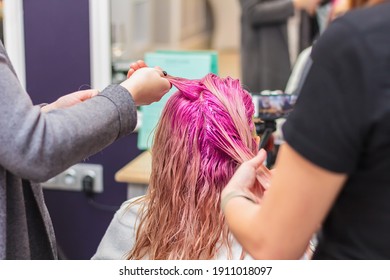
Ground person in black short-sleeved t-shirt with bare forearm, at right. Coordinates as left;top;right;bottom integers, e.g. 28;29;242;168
221;1;390;259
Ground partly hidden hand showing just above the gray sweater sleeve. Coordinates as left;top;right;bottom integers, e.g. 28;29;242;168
41;89;99;112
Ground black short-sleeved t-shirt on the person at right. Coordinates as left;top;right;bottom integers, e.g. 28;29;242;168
283;2;390;259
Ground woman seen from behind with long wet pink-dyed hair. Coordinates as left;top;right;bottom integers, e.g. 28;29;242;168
93;74;270;260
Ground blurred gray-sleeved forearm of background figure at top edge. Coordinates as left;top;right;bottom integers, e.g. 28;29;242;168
240;0;294;27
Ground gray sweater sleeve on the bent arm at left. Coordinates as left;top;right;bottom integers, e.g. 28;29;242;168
0;44;137;182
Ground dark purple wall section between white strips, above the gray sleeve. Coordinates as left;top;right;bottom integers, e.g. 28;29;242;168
23;0;90;103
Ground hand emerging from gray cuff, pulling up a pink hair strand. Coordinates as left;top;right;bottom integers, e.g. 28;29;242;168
121;67;171;106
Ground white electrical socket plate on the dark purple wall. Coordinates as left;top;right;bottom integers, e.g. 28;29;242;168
42;163;103;193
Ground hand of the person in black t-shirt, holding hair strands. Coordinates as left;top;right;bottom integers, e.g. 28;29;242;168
222;149;267;201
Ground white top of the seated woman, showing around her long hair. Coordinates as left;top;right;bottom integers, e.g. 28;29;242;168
92;197;252;260
